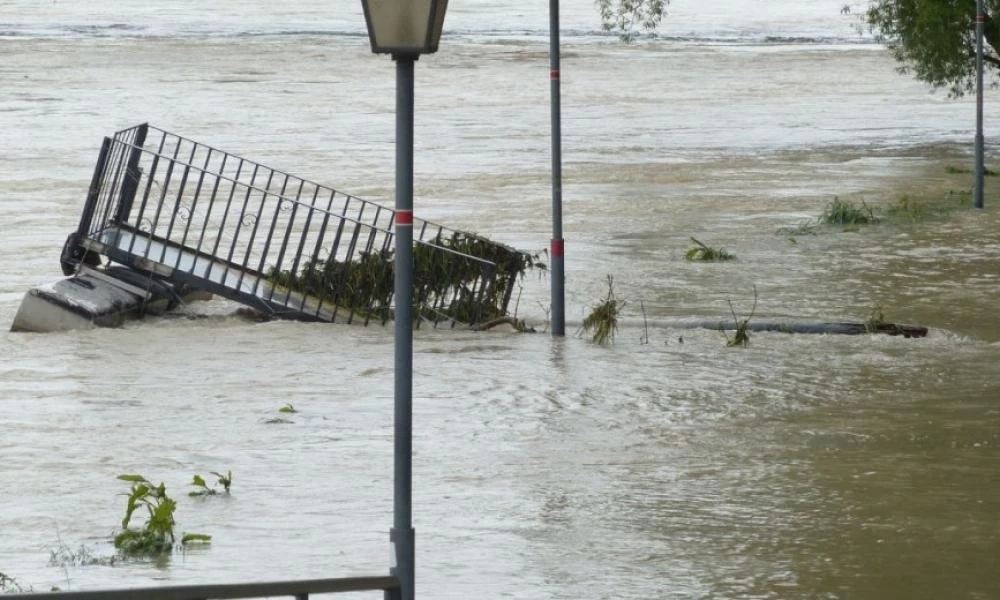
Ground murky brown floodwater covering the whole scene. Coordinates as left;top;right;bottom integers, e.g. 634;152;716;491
0;0;1000;599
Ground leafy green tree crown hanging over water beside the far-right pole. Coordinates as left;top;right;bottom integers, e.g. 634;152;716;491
843;0;1000;96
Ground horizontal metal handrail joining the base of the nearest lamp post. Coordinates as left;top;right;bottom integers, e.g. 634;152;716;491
3;575;399;600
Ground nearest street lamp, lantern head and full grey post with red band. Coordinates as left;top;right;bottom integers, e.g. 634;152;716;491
361;0;448;600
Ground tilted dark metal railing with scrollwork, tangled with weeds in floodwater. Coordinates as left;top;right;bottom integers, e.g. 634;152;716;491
64;124;527;325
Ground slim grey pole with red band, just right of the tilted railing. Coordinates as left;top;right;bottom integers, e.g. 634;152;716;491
549;0;566;336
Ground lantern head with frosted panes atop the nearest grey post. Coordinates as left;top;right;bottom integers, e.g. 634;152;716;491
361;0;448;58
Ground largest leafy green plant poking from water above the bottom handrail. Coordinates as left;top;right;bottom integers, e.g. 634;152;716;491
114;474;210;557
